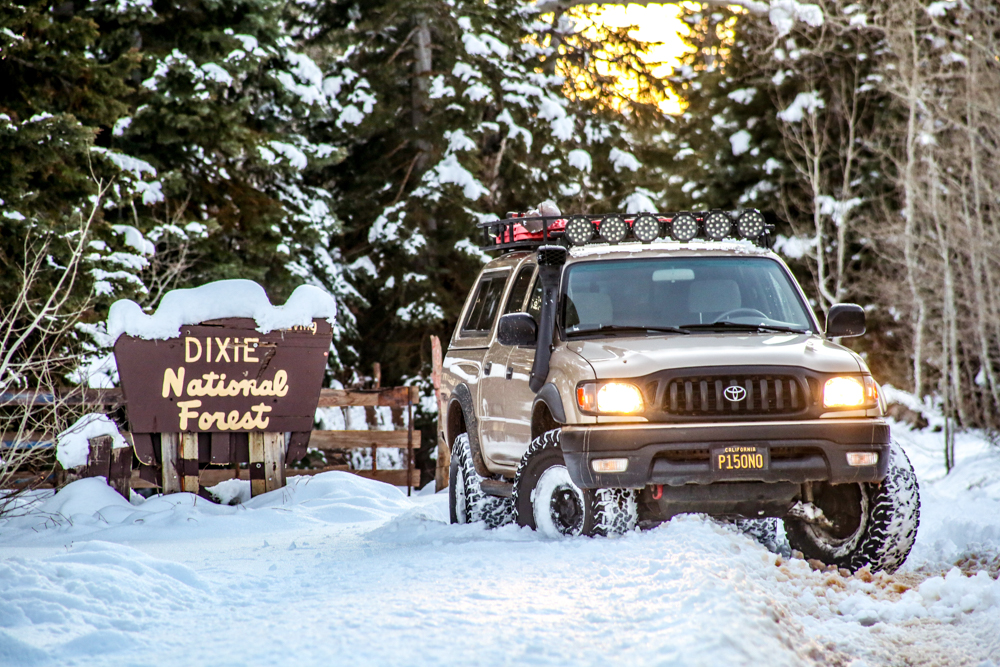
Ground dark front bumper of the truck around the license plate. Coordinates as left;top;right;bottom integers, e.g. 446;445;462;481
560;419;889;489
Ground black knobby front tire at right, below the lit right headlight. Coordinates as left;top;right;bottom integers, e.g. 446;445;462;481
785;443;920;573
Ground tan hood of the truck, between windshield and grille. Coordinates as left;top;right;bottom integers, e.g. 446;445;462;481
566;333;867;378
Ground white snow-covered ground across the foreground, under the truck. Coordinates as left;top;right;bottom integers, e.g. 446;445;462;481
0;426;1000;667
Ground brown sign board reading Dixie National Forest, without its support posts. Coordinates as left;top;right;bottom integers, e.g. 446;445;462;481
115;318;333;433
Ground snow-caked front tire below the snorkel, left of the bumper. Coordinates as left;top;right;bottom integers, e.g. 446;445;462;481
511;429;638;537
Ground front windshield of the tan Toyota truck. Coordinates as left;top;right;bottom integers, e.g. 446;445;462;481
560;257;814;336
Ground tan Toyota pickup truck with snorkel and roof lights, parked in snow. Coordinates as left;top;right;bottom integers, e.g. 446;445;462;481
442;210;920;571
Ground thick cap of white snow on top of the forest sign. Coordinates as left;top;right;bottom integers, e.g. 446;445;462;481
108;280;337;340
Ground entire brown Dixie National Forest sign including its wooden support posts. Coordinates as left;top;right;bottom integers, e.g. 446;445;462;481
115;318;333;495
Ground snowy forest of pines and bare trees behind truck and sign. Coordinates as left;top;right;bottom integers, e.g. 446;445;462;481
0;0;1000;480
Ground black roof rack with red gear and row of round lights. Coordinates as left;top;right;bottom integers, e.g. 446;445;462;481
477;208;777;253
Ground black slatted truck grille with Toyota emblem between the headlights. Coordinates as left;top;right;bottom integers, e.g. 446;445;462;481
663;375;808;416
